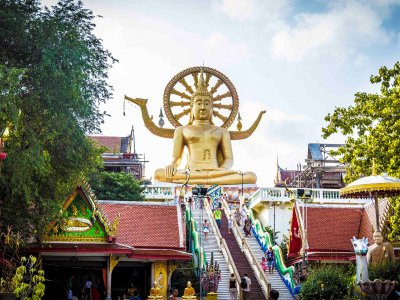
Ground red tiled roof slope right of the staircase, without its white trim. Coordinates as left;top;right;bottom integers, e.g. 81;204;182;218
300;206;363;252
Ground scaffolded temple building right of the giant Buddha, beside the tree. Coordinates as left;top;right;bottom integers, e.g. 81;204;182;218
274;143;345;189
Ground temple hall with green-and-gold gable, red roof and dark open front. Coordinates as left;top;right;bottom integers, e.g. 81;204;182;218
31;184;192;299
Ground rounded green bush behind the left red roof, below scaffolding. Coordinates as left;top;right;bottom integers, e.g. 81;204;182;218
89;172;144;201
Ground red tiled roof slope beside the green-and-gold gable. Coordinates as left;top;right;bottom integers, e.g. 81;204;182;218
98;201;185;250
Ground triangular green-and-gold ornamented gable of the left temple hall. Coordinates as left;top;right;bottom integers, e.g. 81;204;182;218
43;181;120;242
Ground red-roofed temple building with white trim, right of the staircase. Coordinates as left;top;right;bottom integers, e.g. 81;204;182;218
288;199;389;265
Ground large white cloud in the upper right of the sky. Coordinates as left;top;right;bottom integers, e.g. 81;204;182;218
271;1;388;62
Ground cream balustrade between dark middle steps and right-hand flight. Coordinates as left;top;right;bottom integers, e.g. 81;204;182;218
222;199;271;297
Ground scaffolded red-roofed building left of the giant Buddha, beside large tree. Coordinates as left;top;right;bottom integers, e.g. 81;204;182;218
89;128;148;180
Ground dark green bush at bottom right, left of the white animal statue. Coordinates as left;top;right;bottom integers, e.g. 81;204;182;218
300;265;349;300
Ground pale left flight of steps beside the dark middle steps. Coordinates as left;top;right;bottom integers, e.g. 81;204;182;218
192;208;231;300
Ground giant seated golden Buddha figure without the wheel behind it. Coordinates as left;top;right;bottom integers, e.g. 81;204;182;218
154;71;257;185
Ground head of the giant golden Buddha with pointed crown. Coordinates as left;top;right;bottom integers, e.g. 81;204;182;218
189;69;213;124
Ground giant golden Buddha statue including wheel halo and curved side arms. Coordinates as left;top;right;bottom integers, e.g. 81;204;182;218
125;68;265;185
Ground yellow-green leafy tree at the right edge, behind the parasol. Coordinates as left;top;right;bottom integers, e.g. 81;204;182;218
322;62;400;240
